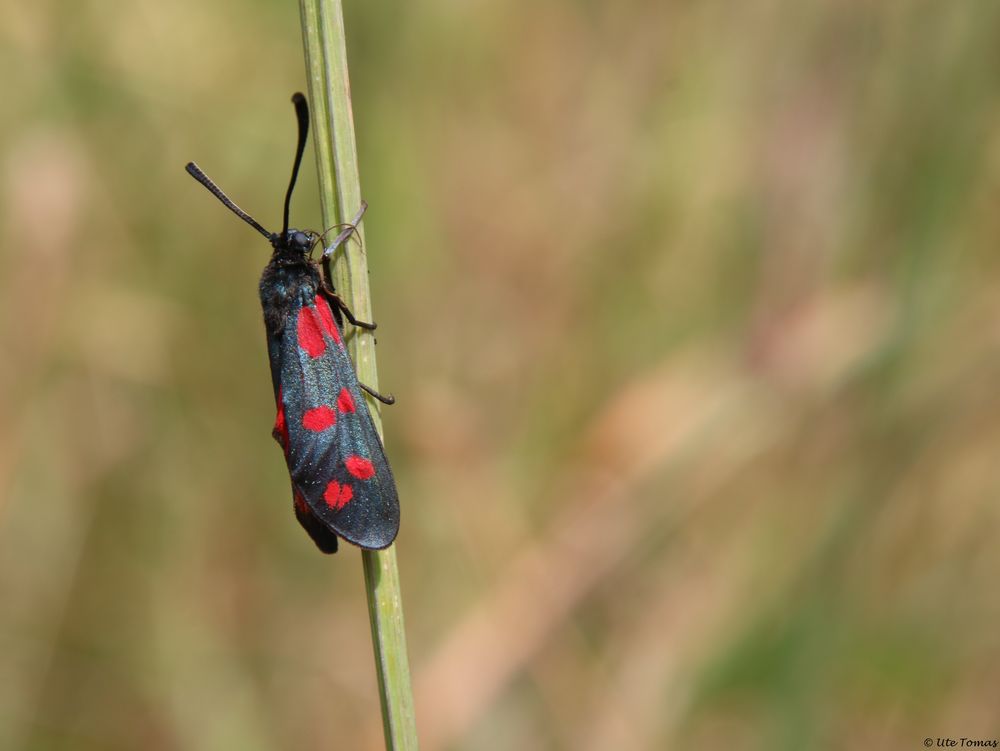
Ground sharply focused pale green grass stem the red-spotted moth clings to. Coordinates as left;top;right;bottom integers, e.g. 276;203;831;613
299;0;417;751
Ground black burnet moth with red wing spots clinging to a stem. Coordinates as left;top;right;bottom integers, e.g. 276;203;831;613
186;94;399;553
